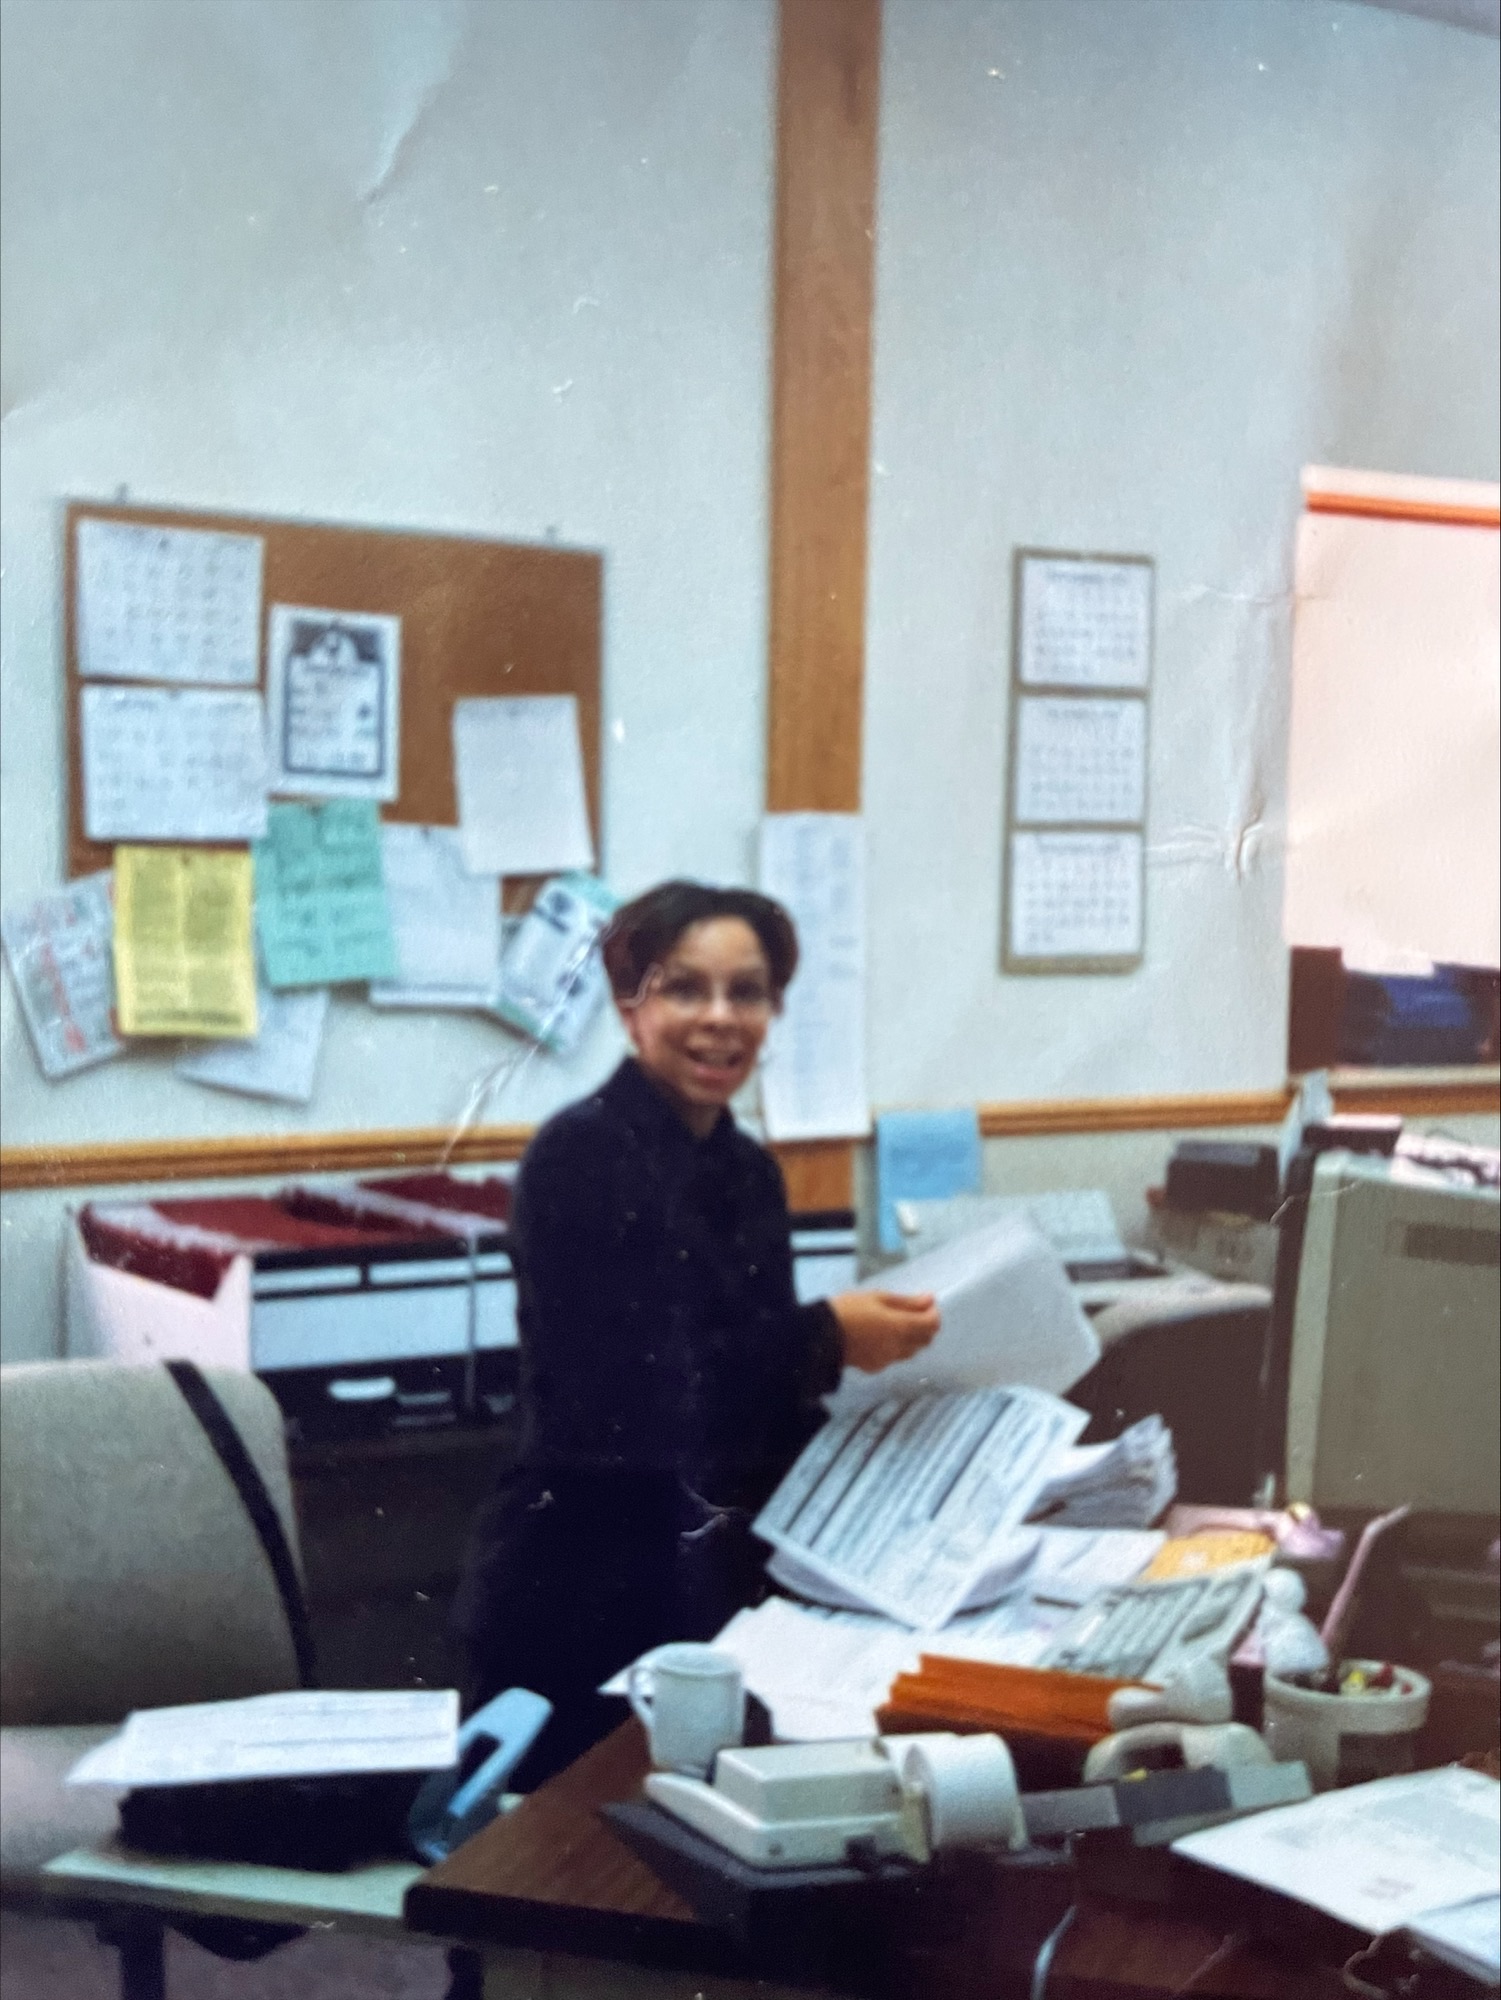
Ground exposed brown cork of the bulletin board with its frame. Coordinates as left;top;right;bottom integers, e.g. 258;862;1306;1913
64;500;604;906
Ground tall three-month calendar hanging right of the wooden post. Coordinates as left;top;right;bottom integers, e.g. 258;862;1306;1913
1001;548;1153;972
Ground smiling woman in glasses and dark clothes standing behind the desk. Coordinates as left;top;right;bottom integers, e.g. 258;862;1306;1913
454;882;939;1784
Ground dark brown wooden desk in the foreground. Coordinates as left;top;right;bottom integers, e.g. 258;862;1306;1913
406;1722;1343;2000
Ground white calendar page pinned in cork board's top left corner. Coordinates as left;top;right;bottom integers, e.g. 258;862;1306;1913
76;520;264;688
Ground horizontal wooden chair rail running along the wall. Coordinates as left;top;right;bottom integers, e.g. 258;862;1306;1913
0;1068;1501;1210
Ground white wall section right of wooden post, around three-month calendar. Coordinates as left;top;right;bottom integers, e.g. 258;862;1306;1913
865;0;1497;1104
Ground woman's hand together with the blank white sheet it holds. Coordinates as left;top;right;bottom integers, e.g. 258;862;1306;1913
827;1214;1099;1416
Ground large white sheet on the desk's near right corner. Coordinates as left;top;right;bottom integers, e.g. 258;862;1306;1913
1173;1764;1501;1934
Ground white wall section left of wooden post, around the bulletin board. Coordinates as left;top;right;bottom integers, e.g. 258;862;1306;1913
0;0;788;1144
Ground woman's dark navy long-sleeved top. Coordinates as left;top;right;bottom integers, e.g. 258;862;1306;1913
510;1060;841;1506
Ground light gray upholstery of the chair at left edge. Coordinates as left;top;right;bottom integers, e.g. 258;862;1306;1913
0;1360;298;1886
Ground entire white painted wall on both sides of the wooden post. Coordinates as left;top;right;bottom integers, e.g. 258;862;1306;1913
0;0;1497;1356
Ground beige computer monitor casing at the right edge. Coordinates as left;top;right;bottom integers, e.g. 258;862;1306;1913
1287;1152;1501;1514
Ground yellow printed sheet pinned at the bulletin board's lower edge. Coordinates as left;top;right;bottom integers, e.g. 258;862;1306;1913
114;846;256;1036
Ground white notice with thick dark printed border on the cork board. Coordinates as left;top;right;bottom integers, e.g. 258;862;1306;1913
266;604;402;800
